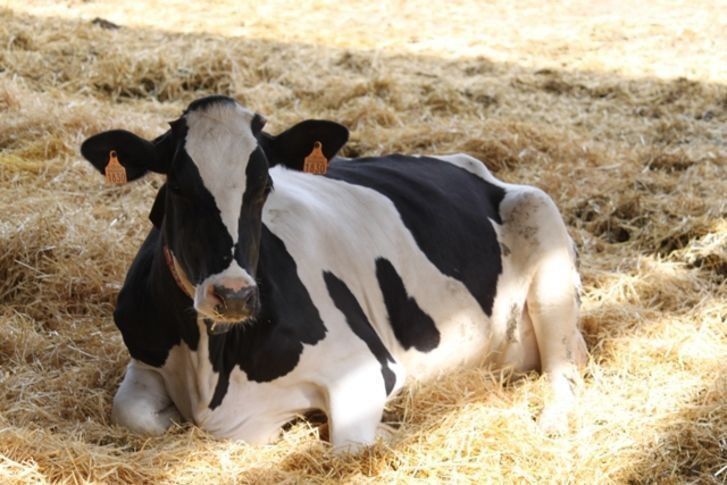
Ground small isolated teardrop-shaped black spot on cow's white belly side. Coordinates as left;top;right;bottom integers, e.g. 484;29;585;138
376;258;440;352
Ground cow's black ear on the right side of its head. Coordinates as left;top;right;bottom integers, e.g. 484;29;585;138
258;120;348;170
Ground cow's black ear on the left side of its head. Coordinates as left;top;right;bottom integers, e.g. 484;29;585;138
81;130;173;181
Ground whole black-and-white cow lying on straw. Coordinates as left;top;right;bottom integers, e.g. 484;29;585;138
81;96;587;449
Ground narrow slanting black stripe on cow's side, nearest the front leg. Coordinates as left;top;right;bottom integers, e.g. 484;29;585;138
323;271;396;396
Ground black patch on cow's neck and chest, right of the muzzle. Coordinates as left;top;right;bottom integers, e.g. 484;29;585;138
209;225;326;409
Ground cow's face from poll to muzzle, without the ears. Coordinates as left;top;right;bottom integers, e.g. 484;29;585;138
163;98;272;322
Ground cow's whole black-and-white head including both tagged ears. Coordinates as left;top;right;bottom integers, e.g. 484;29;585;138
81;96;348;323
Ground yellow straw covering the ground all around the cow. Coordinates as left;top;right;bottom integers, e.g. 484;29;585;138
0;0;727;483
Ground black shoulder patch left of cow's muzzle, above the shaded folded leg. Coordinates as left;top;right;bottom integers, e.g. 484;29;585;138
114;228;199;367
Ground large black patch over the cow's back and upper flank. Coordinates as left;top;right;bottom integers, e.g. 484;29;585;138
325;155;505;316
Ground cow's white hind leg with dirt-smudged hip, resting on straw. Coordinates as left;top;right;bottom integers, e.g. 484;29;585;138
501;187;588;432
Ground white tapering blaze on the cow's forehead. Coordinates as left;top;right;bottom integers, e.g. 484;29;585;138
184;102;257;245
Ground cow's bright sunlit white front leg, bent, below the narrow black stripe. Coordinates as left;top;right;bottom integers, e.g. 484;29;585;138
327;362;387;453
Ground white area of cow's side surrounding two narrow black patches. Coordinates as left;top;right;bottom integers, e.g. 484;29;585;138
263;166;490;382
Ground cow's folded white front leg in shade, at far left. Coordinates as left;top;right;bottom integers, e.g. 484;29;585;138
111;359;181;435
